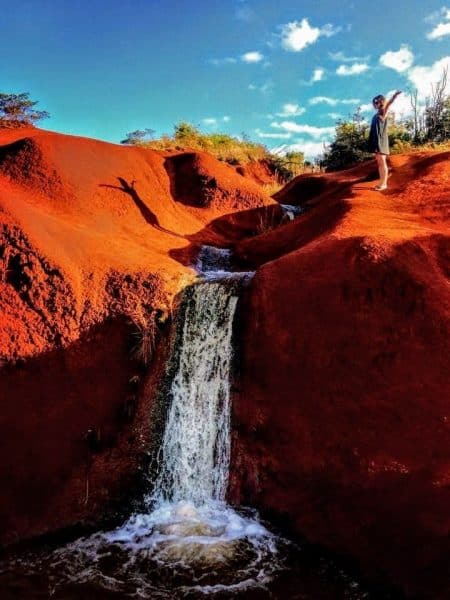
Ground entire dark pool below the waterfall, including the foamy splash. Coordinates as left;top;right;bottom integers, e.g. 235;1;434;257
0;502;398;600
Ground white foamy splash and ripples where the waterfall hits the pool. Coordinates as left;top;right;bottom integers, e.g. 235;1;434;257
37;502;280;598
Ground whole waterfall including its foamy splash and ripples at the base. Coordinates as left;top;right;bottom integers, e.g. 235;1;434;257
18;264;284;600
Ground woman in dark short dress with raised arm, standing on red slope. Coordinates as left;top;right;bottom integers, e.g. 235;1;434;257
369;91;401;191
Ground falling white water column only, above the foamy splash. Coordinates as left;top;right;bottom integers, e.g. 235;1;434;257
151;280;239;505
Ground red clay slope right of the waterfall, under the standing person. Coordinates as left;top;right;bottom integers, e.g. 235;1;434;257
232;153;450;599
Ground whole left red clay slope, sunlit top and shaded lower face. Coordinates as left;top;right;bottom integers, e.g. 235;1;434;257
0;129;274;541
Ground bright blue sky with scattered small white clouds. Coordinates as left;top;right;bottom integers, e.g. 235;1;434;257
0;0;450;156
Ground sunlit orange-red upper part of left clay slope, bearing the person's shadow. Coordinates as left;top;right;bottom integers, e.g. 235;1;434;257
0;129;272;358
